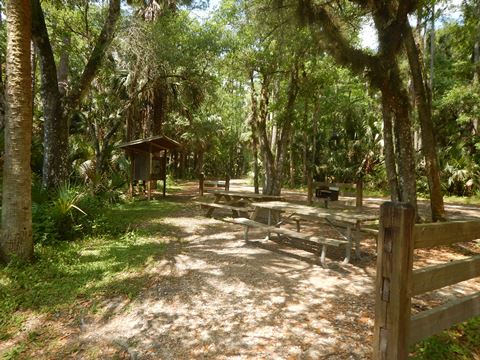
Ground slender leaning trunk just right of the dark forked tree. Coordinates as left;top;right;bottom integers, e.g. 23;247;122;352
405;25;445;222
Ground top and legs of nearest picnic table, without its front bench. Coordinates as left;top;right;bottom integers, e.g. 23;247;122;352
251;201;378;262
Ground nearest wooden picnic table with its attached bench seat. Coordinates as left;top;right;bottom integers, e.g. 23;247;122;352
233;201;378;265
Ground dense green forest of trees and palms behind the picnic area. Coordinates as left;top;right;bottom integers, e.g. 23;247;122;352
0;0;480;260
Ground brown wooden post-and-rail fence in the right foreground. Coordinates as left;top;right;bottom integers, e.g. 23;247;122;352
373;202;480;360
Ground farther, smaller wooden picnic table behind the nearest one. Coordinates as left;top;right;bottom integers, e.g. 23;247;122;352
197;190;282;217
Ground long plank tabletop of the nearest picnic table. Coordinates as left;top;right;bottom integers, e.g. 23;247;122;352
251;201;378;223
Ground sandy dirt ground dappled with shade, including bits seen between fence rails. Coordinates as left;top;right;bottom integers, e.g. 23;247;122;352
3;181;480;359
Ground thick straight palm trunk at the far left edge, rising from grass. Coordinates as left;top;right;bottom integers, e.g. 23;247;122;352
0;0;33;262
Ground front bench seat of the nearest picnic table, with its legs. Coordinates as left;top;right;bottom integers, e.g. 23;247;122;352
224;217;351;267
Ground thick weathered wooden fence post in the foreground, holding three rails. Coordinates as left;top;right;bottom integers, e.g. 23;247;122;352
373;202;415;360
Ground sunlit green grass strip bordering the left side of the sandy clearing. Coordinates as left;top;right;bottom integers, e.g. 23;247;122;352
0;201;182;344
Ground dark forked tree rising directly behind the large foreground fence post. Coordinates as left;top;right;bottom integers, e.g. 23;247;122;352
297;0;417;211
